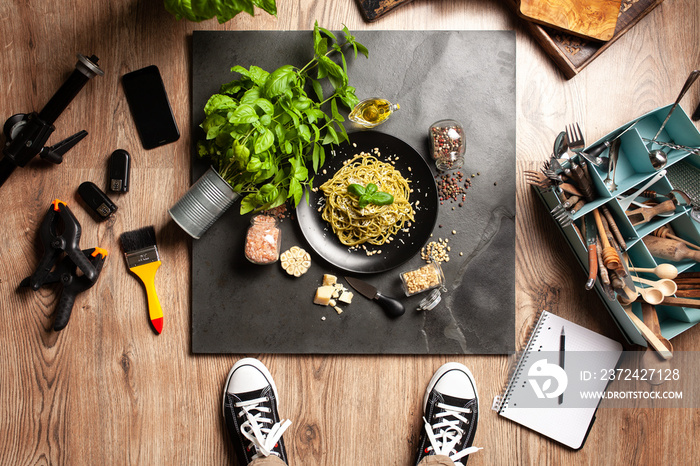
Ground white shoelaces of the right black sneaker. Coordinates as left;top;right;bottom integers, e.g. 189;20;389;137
423;403;482;464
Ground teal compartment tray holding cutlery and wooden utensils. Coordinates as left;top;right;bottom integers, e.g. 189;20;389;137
535;105;700;346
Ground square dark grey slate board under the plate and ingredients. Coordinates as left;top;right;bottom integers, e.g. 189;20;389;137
192;31;515;354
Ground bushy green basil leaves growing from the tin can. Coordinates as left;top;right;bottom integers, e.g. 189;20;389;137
198;21;370;214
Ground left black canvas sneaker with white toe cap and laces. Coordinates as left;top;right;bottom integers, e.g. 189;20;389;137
223;358;292;466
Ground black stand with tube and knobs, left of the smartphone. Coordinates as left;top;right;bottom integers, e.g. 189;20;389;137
0;54;104;186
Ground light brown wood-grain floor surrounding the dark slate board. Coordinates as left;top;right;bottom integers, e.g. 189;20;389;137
0;0;700;466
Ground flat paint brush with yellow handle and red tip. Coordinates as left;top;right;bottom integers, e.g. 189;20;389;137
119;226;163;334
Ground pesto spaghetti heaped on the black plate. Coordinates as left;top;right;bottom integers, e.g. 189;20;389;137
320;152;415;246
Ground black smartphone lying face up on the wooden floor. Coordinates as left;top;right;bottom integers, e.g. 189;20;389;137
122;65;180;149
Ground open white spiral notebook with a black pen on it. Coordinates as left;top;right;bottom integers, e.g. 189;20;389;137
492;311;622;450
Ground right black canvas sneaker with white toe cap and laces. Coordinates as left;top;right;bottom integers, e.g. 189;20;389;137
416;362;481;466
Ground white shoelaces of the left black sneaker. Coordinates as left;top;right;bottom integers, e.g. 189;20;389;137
234;397;292;458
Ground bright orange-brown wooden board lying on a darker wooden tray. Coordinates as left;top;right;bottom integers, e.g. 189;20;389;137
520;0;622;41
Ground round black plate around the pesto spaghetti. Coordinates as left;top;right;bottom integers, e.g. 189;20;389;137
296;131;438;273
